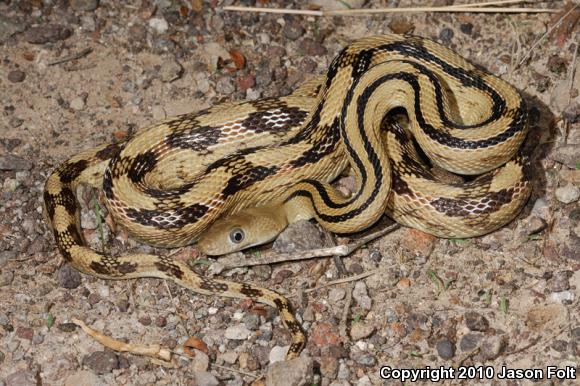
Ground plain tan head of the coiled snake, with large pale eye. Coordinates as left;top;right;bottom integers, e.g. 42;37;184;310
197;205;288;256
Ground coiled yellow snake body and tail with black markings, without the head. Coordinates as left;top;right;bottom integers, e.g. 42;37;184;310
44;35;530;359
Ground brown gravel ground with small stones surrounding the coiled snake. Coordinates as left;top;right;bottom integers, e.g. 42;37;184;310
0;0;580;386
